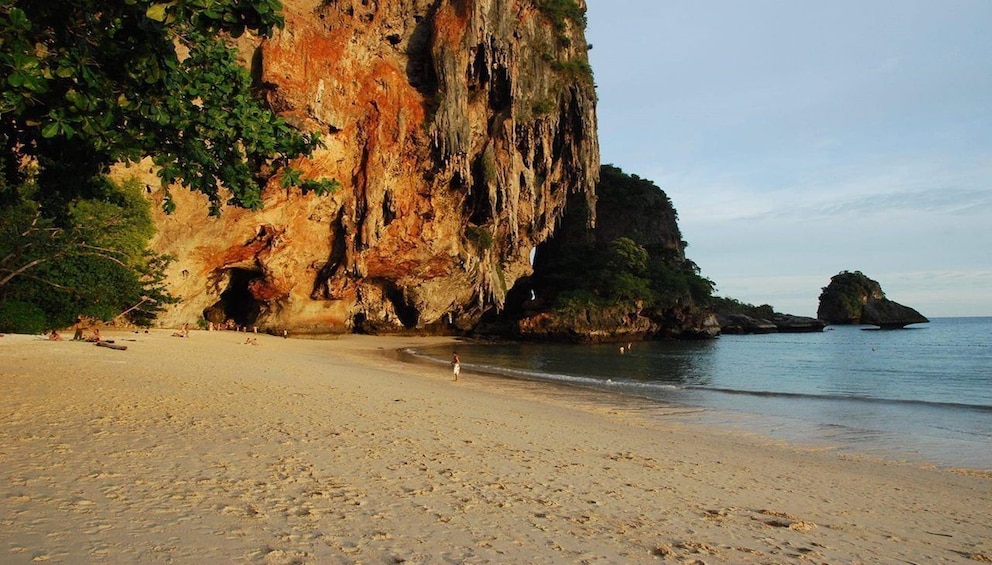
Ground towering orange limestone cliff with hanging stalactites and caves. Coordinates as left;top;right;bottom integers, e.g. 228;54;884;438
142;0;599;333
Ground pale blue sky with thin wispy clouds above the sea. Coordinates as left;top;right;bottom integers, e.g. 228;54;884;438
586;0;992;318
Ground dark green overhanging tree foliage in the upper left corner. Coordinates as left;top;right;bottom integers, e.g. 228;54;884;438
0;0;330;218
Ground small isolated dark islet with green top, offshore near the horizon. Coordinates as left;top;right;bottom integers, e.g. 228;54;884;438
816;271;930;328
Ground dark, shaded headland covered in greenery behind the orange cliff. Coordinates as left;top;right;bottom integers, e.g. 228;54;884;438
494;165;720;342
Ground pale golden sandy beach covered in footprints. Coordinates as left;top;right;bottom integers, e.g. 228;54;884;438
0;330;992;563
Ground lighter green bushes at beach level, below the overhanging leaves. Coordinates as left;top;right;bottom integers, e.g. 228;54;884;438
0;180;175;332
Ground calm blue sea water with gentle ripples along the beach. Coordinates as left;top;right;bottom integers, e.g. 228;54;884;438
405;317;992;471
